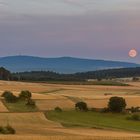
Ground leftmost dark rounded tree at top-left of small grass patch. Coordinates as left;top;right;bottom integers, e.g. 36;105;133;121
2;91;18;103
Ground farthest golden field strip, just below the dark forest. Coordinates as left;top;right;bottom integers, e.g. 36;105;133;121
0;81;140;94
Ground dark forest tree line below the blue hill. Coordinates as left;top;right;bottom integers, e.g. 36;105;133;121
0;67;140;81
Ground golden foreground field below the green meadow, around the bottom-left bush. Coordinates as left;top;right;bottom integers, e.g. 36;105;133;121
0;113;140;140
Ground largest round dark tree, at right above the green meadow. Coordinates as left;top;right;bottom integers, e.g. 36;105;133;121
108;97;126;112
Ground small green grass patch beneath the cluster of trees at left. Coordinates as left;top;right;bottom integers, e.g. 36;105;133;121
3;100;38;112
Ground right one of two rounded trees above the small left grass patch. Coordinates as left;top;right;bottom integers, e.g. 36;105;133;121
19;90;32;100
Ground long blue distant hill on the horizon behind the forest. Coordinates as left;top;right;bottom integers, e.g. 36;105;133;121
0;56;140;73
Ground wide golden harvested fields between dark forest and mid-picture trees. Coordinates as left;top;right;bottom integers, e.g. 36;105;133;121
0;81;140;110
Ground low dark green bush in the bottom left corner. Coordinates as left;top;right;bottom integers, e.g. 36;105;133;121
0;125;16;134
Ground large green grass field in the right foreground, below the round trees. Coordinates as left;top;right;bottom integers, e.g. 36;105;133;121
45;110;140;132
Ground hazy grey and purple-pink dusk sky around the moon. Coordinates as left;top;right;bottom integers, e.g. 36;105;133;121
0;0;140;63
